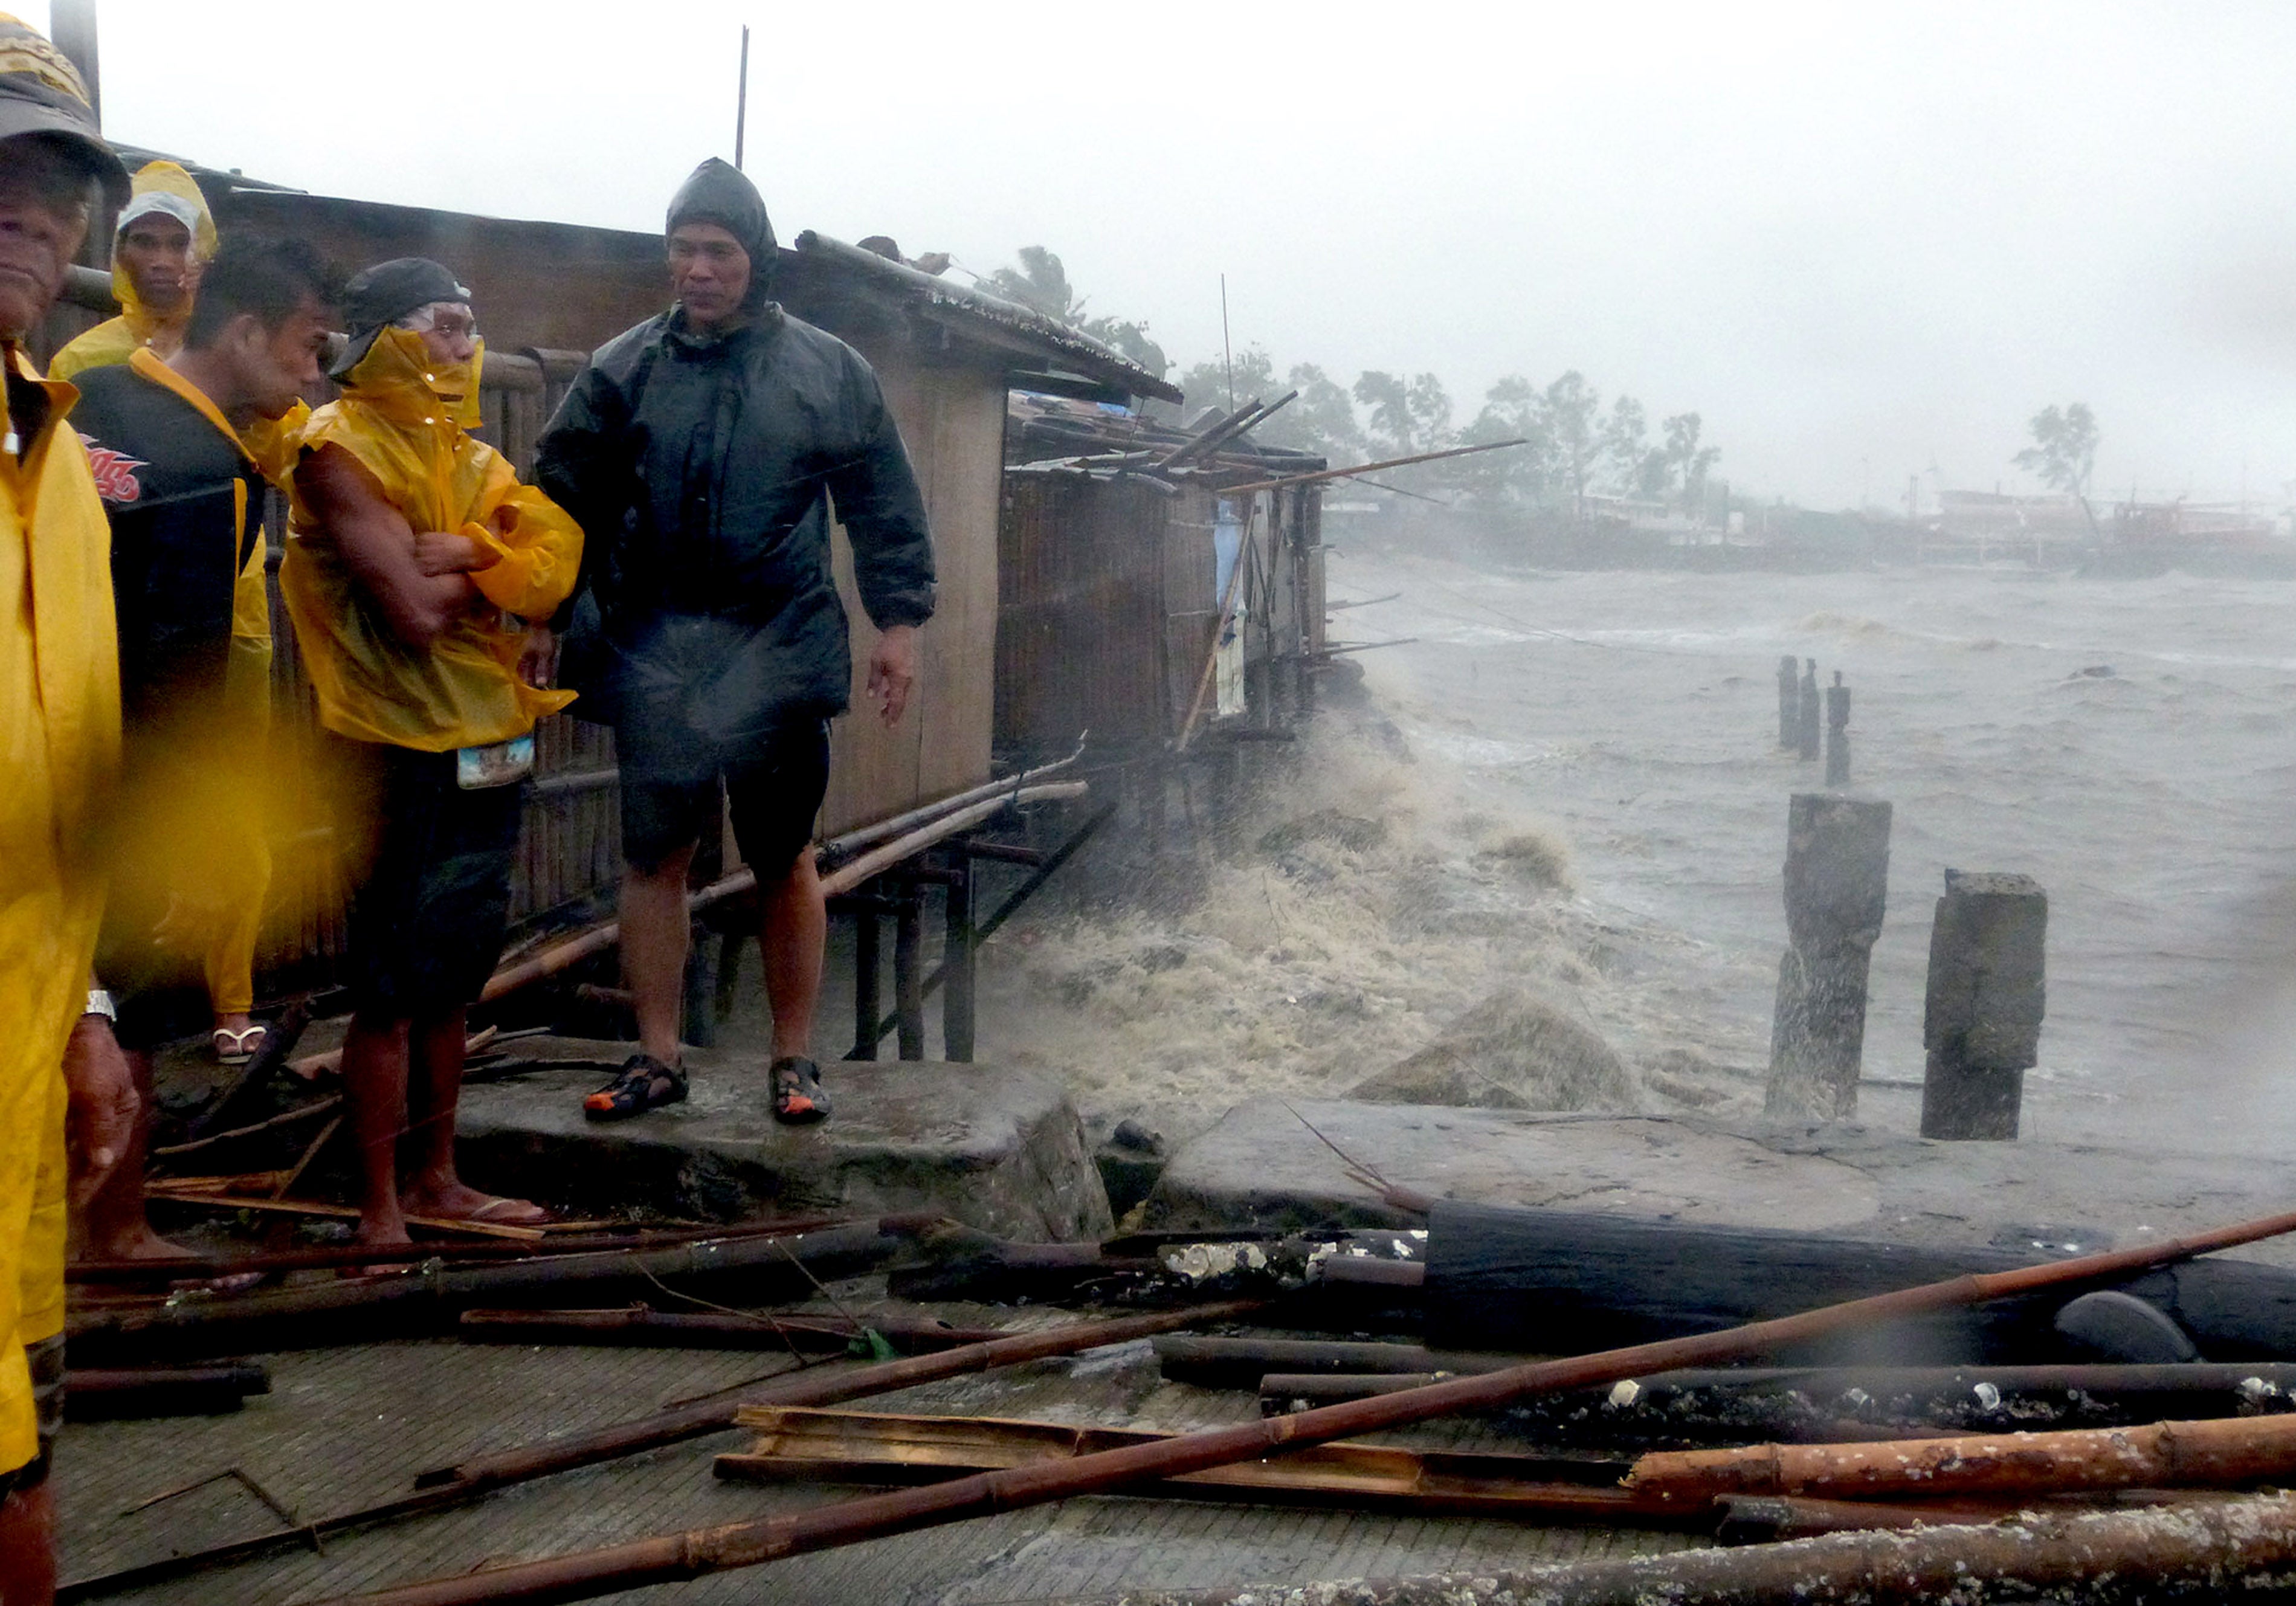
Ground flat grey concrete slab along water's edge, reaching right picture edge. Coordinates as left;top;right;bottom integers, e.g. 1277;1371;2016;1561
1146;1100;2296;1263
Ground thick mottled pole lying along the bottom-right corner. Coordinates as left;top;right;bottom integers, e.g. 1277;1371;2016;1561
1042;1494;2296;1606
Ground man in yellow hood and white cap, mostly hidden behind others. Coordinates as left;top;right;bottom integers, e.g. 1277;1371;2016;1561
48;161;280;1066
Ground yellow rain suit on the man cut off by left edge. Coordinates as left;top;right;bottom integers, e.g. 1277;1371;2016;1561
0;354;120;1471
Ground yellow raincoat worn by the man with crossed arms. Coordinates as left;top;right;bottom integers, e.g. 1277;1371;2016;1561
280;329;581;753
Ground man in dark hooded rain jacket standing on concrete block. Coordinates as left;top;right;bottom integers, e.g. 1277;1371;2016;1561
535;158;932;1121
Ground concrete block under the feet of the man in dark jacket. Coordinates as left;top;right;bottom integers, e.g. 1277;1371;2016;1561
454;1039;1111;1240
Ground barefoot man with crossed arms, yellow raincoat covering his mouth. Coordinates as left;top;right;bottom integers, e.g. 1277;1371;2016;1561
280;257;581;1243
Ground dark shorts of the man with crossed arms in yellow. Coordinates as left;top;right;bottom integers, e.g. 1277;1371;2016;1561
326;735;526;1020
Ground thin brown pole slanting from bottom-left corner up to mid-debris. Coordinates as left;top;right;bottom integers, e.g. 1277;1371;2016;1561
55;1300;1268;1606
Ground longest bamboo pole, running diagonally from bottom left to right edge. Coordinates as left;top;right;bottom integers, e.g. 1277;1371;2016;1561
314;1213;2296;1606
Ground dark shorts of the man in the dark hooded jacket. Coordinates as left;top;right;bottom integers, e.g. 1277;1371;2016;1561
622;719;829;871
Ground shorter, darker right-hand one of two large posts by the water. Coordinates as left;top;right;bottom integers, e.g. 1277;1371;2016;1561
1922;871;2048;1140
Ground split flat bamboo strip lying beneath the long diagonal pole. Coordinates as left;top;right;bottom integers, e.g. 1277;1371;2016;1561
717;1406;1671;1528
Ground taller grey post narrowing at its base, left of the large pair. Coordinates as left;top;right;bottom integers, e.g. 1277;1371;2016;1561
1763;793;1889;1121
